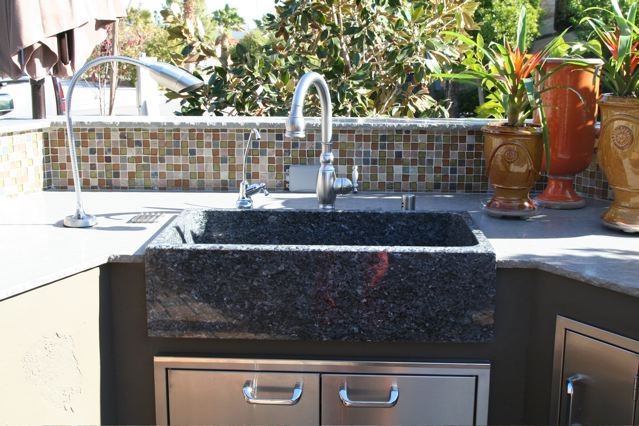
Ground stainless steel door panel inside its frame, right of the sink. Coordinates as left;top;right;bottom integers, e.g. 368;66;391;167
559;330;639;425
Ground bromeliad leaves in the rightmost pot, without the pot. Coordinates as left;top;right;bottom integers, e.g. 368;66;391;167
583;0;639;97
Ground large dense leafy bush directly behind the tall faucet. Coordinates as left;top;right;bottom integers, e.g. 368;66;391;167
170;0;478;117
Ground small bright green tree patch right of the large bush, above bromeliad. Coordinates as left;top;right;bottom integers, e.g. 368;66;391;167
475;0;544;45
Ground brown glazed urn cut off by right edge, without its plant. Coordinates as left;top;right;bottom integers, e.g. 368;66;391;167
598;95;639;232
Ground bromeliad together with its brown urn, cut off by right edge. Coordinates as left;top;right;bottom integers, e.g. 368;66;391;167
585;0;639;232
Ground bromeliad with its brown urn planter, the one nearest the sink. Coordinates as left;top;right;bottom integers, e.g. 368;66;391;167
439;6;561;217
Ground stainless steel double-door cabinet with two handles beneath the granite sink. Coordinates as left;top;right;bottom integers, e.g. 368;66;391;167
155;357;490;425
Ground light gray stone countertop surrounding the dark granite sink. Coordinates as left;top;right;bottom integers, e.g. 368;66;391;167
0;191;639;300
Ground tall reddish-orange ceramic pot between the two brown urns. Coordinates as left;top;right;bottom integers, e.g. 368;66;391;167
536;58;603;209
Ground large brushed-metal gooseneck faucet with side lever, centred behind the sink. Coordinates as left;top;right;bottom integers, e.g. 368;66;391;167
286;72;357;210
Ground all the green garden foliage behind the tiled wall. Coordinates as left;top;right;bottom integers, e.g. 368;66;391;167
92;0;607;117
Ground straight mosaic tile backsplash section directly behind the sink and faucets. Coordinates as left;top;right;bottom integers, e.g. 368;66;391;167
45;122;488;192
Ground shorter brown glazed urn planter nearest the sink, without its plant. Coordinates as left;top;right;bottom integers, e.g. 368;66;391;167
482;125;543;217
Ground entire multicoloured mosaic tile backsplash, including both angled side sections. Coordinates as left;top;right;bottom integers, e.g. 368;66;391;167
0;119;612;199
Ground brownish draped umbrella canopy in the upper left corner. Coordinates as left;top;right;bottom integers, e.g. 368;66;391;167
0;0;126;80
